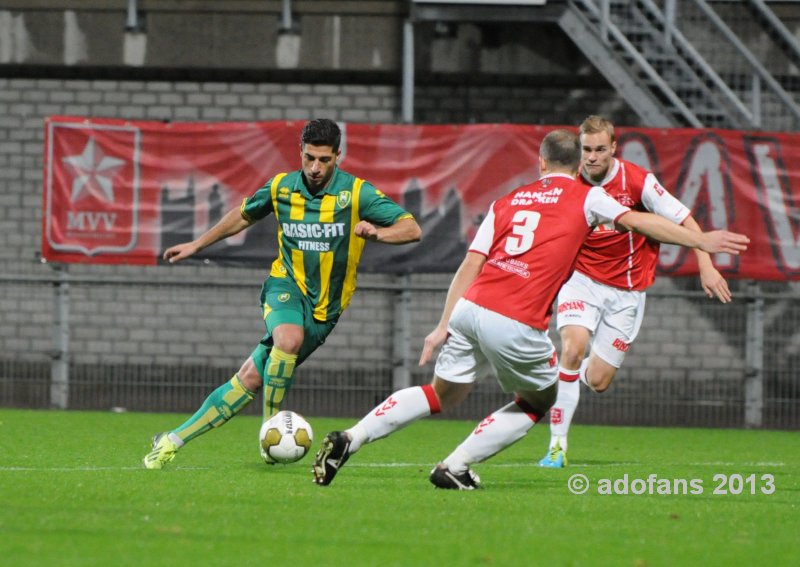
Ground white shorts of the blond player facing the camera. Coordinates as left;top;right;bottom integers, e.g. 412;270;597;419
556;272;645;368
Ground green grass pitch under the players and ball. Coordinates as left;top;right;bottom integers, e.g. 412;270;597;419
0;409;800;567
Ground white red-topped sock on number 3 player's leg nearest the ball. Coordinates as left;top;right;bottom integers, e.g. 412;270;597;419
346;384;441;454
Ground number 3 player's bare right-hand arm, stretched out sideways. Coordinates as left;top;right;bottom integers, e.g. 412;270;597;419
615;211;750;254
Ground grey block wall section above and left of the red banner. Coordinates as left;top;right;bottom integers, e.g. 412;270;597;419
0;78;638;266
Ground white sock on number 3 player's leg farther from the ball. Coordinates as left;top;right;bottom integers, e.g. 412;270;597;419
442;400;541;474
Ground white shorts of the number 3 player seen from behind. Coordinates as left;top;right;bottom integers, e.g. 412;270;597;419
435;299;558;393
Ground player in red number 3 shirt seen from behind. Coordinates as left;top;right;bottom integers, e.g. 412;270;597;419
313;130;747;490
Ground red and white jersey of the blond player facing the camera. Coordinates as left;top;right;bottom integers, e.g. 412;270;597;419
575;159;689;291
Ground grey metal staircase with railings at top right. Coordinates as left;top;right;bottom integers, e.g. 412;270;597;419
562;0;800;130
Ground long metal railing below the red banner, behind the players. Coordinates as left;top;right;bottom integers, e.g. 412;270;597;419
0;267;800;429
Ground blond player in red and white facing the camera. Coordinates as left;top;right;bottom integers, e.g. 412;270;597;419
539;116;731;468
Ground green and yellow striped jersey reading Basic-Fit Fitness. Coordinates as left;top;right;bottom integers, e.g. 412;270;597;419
241;168;412;321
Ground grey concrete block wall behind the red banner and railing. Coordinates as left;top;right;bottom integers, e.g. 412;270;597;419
0;74;742;412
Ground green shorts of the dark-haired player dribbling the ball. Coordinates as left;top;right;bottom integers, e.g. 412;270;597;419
250;277;339;378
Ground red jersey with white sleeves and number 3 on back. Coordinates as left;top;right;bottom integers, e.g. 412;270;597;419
464;174;629;331
